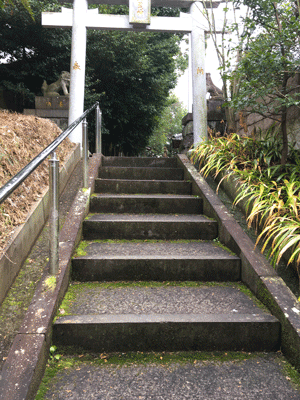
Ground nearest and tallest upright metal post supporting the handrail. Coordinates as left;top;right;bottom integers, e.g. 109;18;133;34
49;151;59;275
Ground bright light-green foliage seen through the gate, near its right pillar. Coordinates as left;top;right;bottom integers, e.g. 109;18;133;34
148;95;187;155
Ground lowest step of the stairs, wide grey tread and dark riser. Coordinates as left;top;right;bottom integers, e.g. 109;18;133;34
53;283;280;352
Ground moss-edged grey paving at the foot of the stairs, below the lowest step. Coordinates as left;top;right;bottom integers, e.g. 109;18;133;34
36;349;300;400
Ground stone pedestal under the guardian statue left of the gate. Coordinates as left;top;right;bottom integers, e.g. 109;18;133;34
24;96;69;130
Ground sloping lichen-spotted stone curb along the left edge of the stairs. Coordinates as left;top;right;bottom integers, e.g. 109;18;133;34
0;154;102;400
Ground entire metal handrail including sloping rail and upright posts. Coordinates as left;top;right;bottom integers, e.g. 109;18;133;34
0;102;102;274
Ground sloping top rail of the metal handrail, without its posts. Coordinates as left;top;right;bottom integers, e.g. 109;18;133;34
0;102;99;204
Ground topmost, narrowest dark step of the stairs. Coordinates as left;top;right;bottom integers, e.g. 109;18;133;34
102;157;177;168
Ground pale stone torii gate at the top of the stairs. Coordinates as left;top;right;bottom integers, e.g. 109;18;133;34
42;0;220;143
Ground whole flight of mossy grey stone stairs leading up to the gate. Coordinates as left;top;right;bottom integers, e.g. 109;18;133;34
53;157;280;352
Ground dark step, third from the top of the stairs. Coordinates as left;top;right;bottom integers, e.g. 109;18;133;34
95;179;192;195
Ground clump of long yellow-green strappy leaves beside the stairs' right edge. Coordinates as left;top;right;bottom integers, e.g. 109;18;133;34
191;130;300;275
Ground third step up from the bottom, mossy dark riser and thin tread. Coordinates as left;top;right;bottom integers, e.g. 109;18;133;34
83;214;218;240
